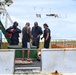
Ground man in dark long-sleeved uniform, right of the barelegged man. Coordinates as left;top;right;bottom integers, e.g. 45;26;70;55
32;22;42;48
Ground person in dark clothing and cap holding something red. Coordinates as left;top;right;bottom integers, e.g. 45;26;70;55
6;22;21;45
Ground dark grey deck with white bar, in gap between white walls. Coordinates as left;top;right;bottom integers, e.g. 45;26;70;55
15;60;41;75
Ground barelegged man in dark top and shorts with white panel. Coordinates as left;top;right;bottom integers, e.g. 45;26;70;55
22;22;31;60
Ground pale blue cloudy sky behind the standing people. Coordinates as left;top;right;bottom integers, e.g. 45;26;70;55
3;0;76;39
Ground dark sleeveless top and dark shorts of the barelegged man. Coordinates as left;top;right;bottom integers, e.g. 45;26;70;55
22;27;30;48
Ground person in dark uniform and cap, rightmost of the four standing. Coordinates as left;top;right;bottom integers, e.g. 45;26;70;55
41;23;51;48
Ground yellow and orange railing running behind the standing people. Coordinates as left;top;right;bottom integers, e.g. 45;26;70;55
2;38;76;49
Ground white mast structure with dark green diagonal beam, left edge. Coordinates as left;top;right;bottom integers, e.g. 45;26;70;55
0;0;13;44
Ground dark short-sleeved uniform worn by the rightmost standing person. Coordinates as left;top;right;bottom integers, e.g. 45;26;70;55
43;28;51;48
